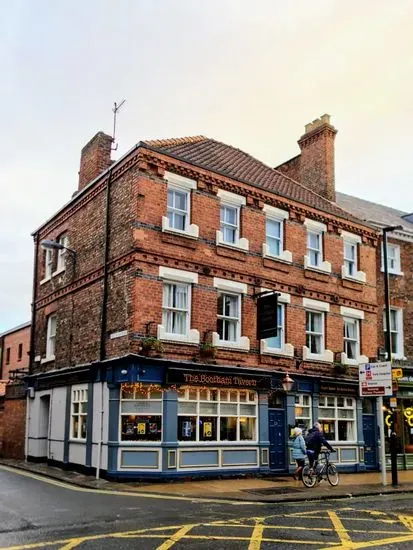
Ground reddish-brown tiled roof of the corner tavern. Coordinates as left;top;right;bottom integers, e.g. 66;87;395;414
143;136;366;225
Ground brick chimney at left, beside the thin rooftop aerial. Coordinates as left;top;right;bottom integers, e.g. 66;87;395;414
78;132;113;191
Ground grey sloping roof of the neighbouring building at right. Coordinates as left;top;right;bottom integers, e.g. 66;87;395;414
336;193;413;234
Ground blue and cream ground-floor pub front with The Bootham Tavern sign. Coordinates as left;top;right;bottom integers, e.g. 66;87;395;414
27;355;364;479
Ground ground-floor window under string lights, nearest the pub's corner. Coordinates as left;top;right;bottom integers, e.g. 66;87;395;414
120;383;162;441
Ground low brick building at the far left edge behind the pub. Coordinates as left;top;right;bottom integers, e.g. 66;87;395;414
0;323;30;458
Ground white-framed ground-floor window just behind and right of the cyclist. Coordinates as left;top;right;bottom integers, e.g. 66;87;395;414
318;395;356;442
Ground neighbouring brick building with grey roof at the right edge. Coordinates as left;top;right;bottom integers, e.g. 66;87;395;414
337;193;413;468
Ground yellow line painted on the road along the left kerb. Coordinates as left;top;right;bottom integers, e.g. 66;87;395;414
0;464;260;506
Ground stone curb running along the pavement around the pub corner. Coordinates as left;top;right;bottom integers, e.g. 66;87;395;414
0;459;413;504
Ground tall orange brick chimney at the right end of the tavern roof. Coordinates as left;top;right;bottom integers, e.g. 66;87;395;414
298;115;337;201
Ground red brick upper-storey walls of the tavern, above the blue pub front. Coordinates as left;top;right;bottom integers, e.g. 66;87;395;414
35;144;377;382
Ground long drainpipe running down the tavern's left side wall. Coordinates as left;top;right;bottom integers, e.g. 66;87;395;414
96;170;112;479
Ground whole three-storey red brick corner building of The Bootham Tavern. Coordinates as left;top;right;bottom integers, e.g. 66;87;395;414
28;117;377;477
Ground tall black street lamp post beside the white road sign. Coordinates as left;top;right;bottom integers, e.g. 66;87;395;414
382;225;403;486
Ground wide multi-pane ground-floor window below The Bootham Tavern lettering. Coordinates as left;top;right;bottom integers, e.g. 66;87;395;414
178;387;257;442
